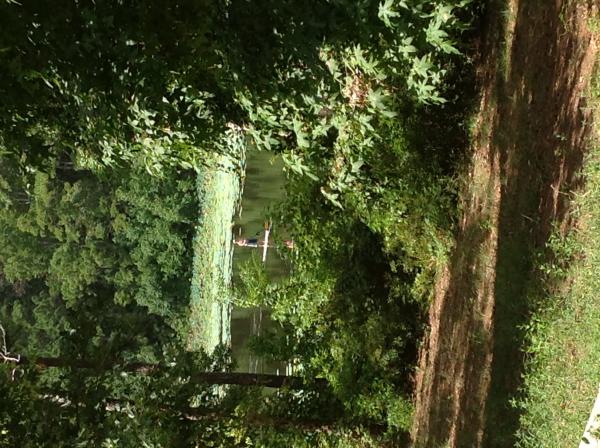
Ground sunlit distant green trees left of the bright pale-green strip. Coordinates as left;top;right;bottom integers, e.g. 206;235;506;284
0;159;198;319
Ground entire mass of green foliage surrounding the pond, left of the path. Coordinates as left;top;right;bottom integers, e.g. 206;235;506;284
0;0;472;447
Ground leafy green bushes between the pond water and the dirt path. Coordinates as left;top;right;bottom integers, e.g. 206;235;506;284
227;2;476;444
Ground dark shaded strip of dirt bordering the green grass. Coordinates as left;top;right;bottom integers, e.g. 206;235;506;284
484;1;591;446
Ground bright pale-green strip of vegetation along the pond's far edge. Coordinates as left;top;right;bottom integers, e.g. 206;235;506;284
187;155;241;353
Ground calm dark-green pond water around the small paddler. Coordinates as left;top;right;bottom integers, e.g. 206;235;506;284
231;151;288;374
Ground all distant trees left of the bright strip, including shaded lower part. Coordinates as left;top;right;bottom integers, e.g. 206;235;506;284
0;158;204;446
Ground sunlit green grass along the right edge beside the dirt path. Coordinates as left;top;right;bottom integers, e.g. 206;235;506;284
514;30;600;448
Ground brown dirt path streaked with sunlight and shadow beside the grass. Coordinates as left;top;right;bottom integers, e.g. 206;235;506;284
412;0;600;448
